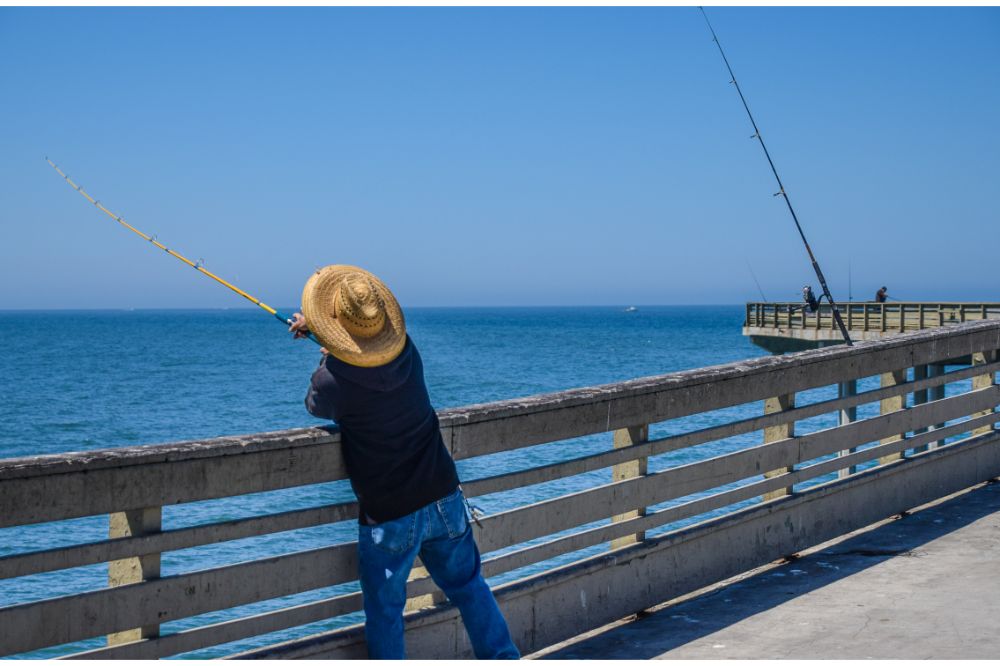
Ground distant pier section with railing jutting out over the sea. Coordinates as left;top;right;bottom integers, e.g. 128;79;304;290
743;302;1000;354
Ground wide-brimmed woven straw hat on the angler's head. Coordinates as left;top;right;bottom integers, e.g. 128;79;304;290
302;264;406;368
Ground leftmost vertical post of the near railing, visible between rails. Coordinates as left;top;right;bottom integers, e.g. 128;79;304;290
108;506;163;645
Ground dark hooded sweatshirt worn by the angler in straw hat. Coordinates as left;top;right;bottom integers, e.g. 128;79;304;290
306;336;458;523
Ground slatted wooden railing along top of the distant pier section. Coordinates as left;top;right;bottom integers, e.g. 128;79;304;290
743;302;1000;333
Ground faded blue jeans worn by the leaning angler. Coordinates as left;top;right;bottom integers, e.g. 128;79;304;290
358;489;520;659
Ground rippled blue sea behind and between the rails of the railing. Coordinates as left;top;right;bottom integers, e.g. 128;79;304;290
0;305;908;658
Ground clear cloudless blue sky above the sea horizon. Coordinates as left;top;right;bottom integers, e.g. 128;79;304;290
0;7;1000;308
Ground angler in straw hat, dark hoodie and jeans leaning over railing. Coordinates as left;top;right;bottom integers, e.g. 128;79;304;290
289;265;520;659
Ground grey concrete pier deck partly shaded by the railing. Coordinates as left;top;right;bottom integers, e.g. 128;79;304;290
535;483;1000;659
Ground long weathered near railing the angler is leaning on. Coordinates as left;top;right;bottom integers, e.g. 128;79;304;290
0;320;1000;658
